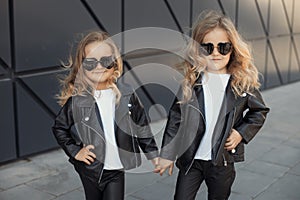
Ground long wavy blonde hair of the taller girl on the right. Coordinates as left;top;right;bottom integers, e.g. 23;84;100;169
182;11;260;102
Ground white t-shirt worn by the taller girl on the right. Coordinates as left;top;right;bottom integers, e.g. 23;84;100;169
195;72;230;160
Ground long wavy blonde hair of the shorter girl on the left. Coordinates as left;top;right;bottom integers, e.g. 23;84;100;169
57;31;123;106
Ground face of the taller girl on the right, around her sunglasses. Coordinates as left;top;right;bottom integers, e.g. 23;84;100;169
201;27;232;74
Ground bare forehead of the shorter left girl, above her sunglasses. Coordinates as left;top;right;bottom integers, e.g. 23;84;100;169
84;42;112;58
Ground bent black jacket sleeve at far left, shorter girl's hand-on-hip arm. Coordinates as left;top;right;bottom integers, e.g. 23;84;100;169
52;97;81;158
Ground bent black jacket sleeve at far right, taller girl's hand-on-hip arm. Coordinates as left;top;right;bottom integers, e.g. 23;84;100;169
234;90;270;144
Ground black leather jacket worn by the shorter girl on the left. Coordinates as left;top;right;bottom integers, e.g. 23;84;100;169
52;83;158;182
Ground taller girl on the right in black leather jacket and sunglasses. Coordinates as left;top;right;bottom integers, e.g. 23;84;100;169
160;11;269;200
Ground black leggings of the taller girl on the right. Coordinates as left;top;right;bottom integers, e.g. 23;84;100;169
174;160;235;200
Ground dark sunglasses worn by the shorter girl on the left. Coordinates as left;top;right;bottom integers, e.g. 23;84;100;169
82;56;116;71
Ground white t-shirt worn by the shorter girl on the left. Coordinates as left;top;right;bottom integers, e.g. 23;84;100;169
94;89;123;170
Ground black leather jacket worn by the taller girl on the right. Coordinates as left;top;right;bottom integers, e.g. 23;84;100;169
161;78;269;173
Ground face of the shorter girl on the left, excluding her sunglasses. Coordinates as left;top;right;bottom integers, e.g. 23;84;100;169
84;42;114;90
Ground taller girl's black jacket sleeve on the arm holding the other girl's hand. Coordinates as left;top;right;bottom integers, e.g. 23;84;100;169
160;95;183;161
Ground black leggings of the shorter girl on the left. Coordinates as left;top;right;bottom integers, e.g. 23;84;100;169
80;170;125;200
